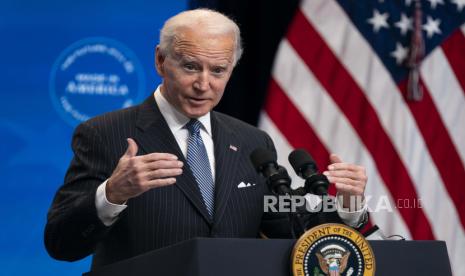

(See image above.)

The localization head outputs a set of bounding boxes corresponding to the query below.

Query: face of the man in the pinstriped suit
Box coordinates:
[156,29,234,118]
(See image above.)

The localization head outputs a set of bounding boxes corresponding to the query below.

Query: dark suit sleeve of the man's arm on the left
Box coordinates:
[44,123,113,261]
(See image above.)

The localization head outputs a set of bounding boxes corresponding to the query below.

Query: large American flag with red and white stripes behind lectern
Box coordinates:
[259,0,465,275]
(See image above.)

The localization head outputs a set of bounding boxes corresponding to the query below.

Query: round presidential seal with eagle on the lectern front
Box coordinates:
[291,223,375,276]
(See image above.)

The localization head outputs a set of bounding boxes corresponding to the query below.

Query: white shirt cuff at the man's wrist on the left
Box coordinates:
[95,180,128,226]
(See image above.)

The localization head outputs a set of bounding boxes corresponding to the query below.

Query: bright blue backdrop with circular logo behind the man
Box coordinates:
[0,0,187,275]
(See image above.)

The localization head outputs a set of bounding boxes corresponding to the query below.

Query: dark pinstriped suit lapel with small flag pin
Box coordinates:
[211,112,241,224]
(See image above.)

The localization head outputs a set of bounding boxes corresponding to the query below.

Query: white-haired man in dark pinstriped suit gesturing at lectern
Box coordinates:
[45,9,366,267]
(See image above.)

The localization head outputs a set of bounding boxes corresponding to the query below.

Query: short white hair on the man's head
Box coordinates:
[159,8,243,65]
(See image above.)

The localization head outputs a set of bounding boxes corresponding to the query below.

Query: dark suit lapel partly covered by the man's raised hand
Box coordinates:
[136,95,212,224]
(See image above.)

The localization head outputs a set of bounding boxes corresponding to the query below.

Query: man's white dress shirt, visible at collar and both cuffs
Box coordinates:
[95,86,367,227]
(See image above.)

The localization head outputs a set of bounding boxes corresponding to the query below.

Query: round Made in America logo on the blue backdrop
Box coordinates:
[50,37,145,126]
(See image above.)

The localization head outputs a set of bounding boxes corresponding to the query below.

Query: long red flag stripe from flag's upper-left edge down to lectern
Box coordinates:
[287,8,434,239]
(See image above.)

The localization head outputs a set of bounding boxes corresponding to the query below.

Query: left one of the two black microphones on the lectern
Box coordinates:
[250,148,292,195]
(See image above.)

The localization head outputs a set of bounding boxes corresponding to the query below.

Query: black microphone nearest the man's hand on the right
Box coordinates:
[288,149,329,196]
